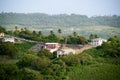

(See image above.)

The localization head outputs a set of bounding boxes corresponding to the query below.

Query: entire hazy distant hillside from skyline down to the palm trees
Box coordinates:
[0,13,120,37]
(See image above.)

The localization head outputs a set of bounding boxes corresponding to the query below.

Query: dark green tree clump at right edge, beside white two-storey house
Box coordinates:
[97,37,120,57]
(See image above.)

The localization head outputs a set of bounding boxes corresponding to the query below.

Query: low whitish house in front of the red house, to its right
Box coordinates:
[57,49,75,58]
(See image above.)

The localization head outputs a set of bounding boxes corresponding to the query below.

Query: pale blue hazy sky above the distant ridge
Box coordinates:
[0,0,120,16]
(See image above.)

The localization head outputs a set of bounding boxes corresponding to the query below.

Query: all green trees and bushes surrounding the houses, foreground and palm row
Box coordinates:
[0,23,120,80]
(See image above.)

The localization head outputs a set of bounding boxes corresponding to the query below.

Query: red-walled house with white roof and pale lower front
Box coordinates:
[45,43,60,53]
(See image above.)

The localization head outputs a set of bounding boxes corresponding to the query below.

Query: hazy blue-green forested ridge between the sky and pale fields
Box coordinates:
[0,13,120,27]
